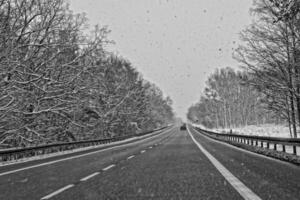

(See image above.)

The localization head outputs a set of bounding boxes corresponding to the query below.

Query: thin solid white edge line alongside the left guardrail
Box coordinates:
[0,128,174,176]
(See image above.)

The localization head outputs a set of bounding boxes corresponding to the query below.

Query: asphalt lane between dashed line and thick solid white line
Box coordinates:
[46,127,241,200]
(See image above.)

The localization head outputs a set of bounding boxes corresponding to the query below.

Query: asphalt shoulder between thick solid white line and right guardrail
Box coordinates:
[190,128,300,200]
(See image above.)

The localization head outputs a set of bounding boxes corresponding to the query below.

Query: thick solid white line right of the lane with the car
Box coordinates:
[187,128,261,200]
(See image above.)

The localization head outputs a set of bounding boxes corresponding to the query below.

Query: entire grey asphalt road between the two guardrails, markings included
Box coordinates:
[0,128,300,200]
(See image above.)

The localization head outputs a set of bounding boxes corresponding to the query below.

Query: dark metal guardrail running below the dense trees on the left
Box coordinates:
[0,126,169,162]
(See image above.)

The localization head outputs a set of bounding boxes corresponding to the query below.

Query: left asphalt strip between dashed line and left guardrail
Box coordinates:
[0,129,173,200]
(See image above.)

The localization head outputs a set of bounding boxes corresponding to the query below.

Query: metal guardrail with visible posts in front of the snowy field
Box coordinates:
[194,127,300,155]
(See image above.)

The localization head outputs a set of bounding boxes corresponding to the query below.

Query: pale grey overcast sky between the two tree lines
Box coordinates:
[69,0,252,118]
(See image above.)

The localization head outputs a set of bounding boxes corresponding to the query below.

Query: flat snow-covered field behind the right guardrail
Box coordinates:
[193,124,300,138]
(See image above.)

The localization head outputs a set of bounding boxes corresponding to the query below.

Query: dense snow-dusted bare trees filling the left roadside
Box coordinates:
[0,0,173,147]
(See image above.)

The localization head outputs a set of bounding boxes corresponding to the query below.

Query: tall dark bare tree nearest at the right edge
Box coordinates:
[236,0,300,137]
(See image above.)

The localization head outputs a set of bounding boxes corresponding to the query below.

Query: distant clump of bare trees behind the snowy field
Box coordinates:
[187,67,281,128]
